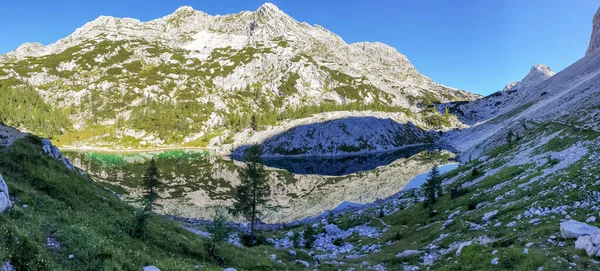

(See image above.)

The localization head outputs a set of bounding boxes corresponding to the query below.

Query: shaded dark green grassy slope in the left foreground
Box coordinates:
[0,137,296,271]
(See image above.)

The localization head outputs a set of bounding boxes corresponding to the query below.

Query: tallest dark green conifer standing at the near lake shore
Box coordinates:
[231,145,270,245]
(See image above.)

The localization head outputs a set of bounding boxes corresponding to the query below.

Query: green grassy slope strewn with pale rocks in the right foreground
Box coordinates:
[254,123,600,270]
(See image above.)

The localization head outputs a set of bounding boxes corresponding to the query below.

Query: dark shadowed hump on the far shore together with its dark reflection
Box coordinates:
[232,117,450,176]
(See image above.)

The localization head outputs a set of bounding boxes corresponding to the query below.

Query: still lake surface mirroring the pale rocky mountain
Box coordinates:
[65,146,453,223]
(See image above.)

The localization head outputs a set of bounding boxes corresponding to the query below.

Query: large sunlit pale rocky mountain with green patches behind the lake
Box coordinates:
[0,4,479,153]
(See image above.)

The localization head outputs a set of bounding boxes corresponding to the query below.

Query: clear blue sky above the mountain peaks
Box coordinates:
[0,0,600,95]
